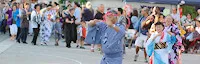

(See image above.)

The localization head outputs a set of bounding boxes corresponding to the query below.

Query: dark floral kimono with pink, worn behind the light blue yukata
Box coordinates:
[164,24,183,64]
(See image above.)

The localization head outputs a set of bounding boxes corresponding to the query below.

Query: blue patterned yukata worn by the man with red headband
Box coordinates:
[85,22,125,64]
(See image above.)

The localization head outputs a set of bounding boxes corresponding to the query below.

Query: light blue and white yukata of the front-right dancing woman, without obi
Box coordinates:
[146,32,176,64]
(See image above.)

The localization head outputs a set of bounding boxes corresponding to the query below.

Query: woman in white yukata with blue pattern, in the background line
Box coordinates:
[40,5,55,45]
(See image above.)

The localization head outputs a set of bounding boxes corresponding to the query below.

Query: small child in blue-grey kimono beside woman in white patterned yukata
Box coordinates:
[53,17,62,46]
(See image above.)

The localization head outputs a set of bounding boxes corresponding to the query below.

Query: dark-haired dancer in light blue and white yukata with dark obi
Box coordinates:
[146,22,176,64]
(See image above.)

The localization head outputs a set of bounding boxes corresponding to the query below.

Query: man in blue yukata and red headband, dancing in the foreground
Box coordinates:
[85,10,125,64]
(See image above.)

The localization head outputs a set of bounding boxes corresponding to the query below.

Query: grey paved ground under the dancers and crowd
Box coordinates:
[0,35,200,64]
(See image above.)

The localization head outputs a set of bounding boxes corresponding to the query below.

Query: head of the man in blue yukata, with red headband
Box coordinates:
[105,10,118,24]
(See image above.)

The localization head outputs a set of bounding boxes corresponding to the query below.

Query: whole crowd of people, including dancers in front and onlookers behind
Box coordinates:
[0,1,200,64]
